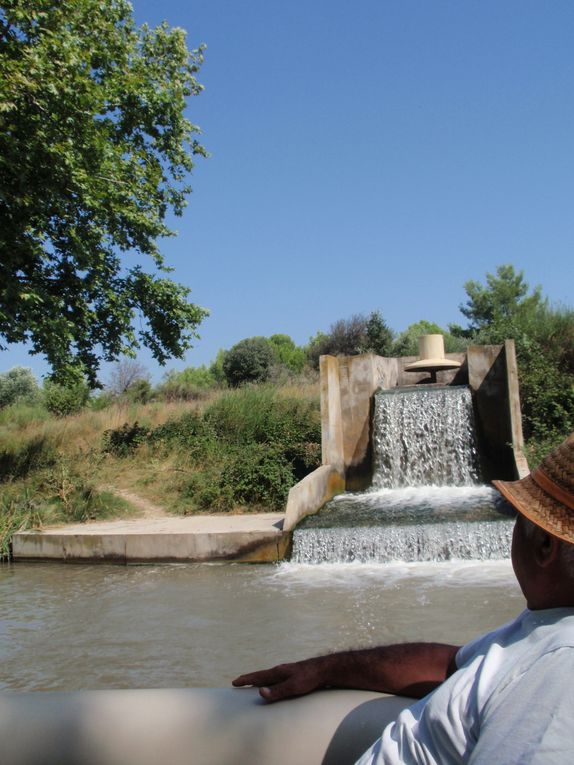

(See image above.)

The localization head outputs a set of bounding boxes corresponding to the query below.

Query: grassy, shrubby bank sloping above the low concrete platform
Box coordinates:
[0,383,321,557]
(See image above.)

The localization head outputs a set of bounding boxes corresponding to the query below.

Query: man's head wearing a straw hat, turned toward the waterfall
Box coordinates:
[494,433,574,609]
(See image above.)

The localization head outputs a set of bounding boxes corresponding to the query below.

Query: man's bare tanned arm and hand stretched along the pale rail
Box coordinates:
[233,643,458,701]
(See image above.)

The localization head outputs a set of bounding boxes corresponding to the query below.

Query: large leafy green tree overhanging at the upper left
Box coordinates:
[0,0,210,385]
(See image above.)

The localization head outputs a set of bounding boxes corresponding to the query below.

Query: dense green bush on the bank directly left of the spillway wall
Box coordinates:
[162,386,321,512]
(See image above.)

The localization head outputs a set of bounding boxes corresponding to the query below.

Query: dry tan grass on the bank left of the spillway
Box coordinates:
[0,380,319,536]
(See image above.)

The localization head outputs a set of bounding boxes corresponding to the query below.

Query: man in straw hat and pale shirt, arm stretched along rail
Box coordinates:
[234,433,574,765]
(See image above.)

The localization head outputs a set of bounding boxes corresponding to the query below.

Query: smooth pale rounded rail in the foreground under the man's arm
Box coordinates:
[0,688,412,765]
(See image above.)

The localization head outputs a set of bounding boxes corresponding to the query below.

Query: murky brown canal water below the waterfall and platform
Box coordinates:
[0,561,524,690]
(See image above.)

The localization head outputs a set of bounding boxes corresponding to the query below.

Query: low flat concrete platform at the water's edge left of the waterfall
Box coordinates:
[12,513,290,564]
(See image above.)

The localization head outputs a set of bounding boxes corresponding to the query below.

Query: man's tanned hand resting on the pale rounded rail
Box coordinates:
[233,656,326,701]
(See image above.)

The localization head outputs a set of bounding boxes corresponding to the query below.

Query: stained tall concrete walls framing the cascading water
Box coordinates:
[284,340,528,529]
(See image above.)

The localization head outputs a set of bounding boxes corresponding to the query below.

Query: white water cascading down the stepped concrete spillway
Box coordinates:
[292,387,513,563]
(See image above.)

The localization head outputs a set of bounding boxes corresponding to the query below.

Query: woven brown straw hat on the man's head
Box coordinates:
[493,433,574,544]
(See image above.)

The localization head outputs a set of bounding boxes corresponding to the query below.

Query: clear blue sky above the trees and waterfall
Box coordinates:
[0,0,574,381]
